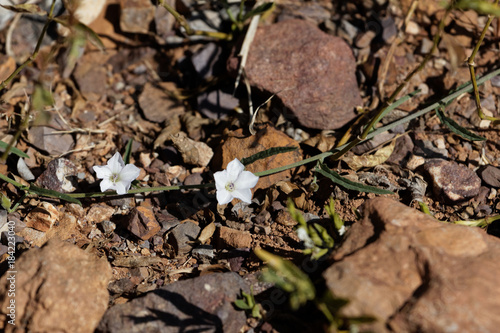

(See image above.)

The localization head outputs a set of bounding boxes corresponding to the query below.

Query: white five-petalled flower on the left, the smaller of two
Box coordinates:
[93,152,140,194]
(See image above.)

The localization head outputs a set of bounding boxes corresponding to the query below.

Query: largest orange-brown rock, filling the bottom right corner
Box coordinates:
[323,198,500,332]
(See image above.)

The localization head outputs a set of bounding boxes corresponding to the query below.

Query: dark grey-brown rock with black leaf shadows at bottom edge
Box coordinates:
[97,273,249,333]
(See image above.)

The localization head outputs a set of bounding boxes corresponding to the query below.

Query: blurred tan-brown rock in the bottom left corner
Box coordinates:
[0,241,111,333]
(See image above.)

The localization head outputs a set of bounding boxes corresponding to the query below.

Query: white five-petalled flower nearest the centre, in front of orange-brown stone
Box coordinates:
[214,158,259,205]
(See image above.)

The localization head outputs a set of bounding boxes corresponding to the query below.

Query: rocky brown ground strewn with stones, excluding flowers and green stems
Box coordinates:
[0,0,500,332]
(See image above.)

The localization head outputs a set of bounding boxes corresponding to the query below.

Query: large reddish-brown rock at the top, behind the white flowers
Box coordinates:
[229,19,363,130]
